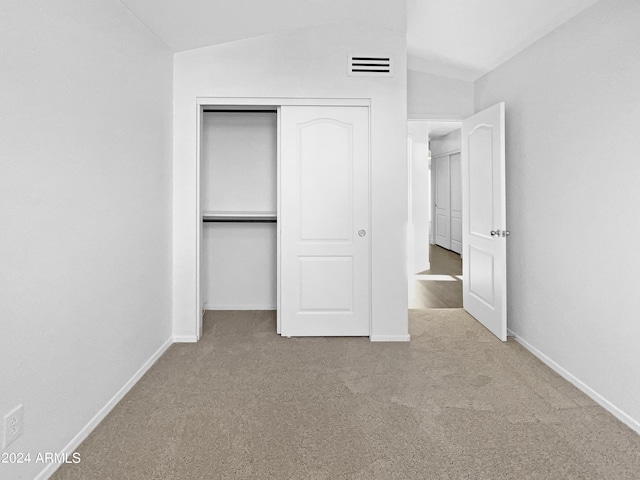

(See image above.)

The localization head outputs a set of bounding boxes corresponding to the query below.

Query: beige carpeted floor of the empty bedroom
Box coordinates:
[53,309,640,480]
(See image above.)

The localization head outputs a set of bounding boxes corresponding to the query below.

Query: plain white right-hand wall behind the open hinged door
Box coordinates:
[476,0,640,431]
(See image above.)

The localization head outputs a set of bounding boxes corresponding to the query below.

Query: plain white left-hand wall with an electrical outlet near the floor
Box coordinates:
[0,0,172,479]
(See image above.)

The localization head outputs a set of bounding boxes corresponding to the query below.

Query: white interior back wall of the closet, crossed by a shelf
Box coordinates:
[200,109,278,310]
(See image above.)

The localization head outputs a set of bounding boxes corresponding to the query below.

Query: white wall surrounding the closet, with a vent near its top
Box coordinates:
[173,24,407,339]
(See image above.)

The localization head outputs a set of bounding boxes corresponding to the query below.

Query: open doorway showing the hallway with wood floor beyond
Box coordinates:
[408,120,463,309]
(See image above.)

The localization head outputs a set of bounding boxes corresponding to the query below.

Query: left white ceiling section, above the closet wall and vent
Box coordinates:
[120,0,407,52]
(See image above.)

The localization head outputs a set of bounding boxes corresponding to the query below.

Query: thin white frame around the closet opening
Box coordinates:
[194,97,372,340]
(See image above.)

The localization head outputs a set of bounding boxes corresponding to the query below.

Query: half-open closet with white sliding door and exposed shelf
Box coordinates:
[197,99,371,336]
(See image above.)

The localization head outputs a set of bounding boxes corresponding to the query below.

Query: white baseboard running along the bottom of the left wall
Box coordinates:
[34,338,173,480]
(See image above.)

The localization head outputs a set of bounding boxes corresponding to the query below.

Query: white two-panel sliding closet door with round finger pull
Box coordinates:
[278,106,370,336]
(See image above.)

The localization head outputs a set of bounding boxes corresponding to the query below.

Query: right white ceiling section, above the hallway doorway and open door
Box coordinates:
[407,0,597,81]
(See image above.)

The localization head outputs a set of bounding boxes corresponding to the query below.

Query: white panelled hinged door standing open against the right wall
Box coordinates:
[462,103,509,341]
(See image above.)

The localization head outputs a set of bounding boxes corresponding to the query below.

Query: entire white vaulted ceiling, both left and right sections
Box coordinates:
[121,0,597,81]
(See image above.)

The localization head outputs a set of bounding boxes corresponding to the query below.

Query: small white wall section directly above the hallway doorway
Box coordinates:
[407,69,474,120]
